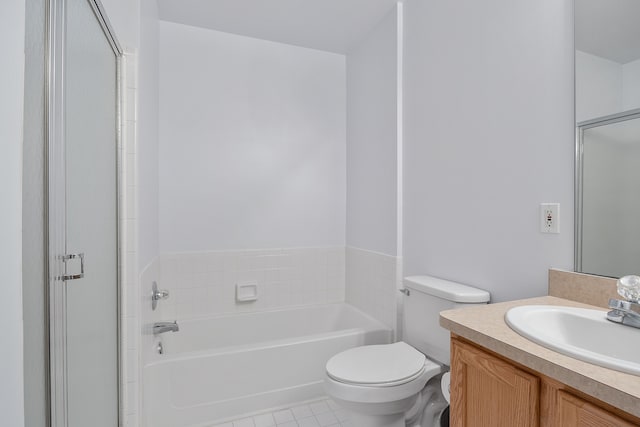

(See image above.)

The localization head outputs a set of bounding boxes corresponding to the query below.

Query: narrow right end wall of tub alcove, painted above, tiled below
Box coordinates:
[345,8,400,329]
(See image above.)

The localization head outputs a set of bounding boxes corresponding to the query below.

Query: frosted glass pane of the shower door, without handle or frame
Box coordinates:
[65,0,118,427]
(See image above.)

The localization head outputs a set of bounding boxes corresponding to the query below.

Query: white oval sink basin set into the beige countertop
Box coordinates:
[505,305,640,375]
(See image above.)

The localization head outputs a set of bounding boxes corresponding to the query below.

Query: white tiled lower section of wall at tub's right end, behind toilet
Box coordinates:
[345,247,401,330]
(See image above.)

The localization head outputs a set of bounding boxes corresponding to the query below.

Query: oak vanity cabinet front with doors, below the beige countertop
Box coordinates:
[450,335,640,427]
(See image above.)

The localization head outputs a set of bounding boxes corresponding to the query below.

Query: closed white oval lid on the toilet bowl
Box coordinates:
[327,342,426,386]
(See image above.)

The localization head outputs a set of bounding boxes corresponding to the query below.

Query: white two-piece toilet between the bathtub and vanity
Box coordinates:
[324,276,490,427]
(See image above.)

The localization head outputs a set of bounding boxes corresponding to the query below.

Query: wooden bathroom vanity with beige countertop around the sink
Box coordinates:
[440,296,640,427]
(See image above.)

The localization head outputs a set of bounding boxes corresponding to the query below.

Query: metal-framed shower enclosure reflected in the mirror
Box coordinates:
[575,110,640,277]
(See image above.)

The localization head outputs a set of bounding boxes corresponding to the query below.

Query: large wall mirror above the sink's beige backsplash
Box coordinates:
[575,0,640,277]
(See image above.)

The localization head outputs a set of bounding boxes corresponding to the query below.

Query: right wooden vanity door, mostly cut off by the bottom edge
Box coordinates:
[553,390,636,427]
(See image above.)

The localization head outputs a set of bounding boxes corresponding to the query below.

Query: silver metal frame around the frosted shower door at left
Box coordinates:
[44,0,124,427]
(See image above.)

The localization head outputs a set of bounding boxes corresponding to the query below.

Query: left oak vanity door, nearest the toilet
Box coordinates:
[451,339,540,427]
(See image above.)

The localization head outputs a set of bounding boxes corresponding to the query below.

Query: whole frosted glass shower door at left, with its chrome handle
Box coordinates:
[50,0,119,427]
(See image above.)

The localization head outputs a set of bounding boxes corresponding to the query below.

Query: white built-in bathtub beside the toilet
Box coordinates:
[143,304,391,427]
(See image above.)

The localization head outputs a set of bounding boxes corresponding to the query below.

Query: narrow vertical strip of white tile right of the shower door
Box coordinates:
[119,51,140,427]
